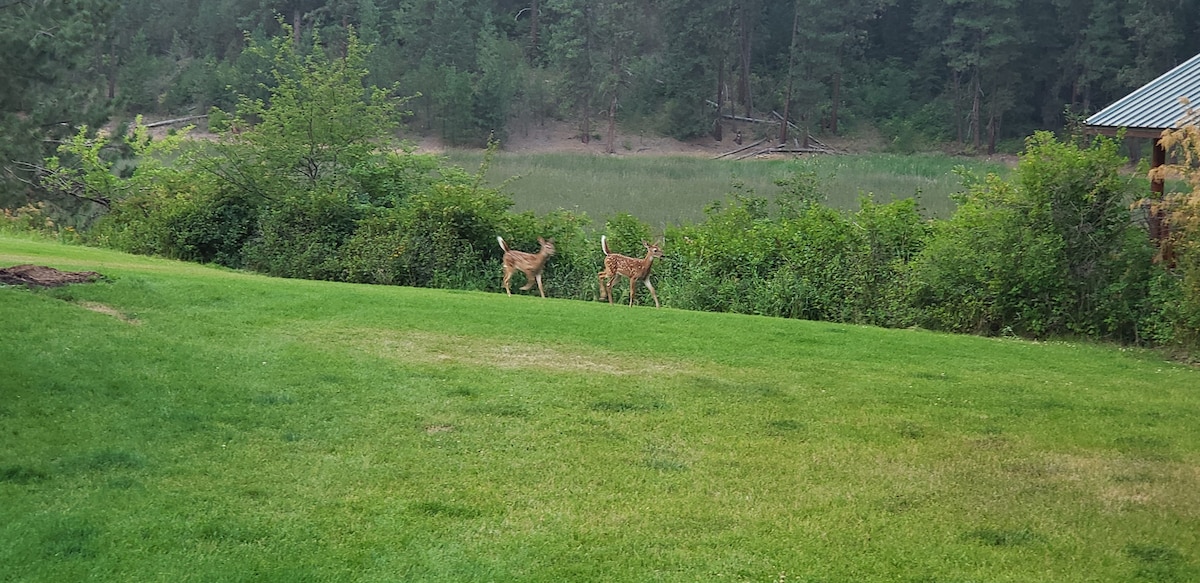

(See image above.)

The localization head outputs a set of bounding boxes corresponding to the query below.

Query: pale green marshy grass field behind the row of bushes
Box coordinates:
[446,150,1008,229]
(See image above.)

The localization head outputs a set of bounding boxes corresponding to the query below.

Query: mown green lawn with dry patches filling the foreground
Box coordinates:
[0,235,1200,583]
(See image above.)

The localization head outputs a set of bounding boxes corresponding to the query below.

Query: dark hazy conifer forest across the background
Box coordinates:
[0,0,1200,172]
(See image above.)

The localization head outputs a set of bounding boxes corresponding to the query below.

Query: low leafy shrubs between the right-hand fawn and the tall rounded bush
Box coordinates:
[661,190,925,325]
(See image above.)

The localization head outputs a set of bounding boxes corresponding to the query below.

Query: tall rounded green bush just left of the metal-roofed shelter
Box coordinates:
[912,133,1150,339]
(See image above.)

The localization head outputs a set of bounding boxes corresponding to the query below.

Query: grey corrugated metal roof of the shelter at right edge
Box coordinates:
[1084,54,1200,138]
